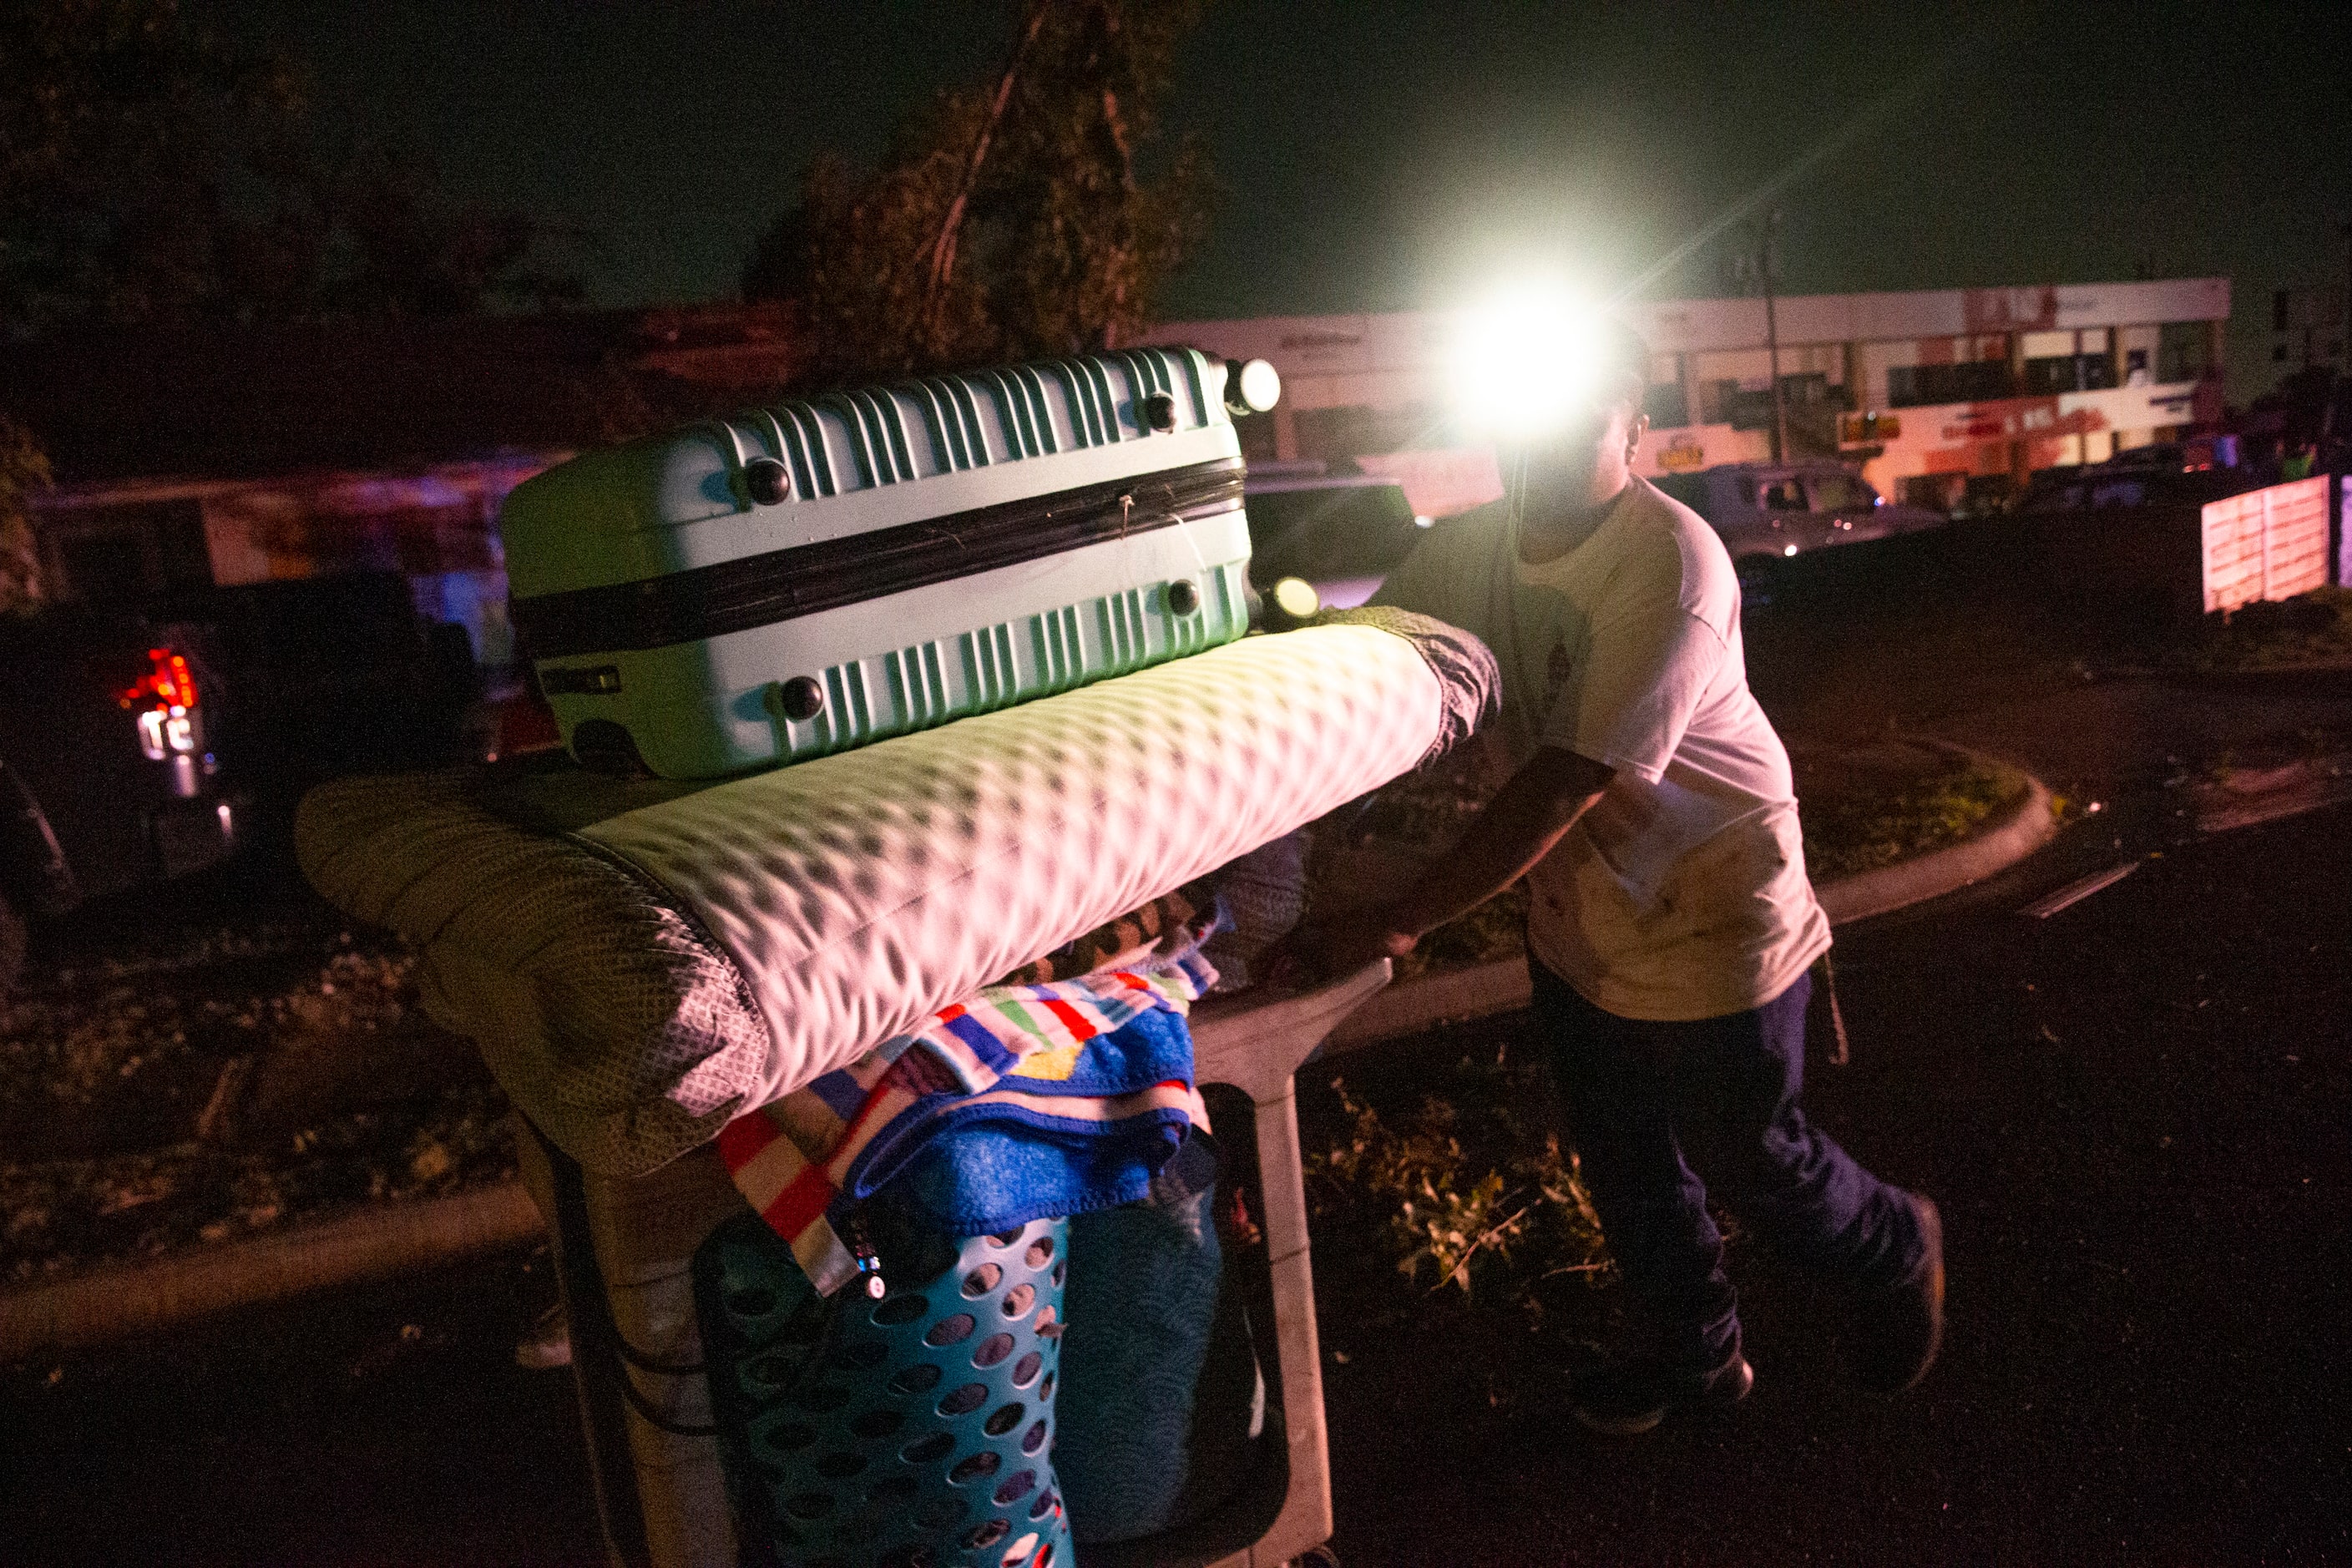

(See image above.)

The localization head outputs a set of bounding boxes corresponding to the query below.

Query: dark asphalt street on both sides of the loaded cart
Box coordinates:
[0,747,2352,1568]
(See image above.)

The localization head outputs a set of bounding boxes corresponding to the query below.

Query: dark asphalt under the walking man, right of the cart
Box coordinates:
[1324,766,2352,1568]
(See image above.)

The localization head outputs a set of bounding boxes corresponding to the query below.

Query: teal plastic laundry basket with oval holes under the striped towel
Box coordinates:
[694,1213,1073,1568]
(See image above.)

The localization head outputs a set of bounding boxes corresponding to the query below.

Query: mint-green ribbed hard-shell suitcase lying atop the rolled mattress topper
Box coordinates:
[498,348,1270,778]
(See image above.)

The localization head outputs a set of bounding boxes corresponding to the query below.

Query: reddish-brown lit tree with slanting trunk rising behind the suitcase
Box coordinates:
[743,0,1211,381]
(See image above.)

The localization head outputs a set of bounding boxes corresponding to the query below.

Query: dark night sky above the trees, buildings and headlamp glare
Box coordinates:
[190,0,2352,397]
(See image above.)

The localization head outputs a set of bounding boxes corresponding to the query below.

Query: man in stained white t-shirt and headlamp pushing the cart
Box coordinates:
[1308,325,1943,1434]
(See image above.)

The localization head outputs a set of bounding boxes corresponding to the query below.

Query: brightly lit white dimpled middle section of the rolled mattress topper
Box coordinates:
[579,625,1451,1103]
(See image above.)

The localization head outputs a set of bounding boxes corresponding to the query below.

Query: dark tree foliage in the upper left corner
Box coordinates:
[0,0,579,331]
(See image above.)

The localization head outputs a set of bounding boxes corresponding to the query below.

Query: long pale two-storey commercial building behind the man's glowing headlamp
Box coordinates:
[1152,277,2230,515]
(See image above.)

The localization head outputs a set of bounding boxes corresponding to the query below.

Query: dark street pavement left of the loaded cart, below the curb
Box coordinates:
[0,1257,604,1568]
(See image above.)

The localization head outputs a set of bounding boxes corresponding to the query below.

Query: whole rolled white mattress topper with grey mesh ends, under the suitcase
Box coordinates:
[294,609,1496,1176]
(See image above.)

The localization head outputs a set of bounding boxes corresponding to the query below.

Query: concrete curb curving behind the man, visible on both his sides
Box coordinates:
[1322,743,2058,1055]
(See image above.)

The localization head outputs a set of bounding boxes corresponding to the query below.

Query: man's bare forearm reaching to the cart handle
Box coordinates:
[1305,746,1616,974]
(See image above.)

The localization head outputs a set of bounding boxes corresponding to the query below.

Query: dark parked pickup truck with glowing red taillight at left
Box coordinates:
[0,571,484,999]
